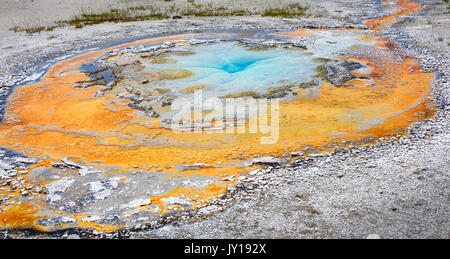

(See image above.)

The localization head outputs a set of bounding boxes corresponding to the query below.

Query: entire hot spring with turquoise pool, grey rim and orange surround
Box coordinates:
[0,0,434,236]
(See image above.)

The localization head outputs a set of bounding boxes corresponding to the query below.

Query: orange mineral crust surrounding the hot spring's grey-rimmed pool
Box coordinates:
[0,0,434,232]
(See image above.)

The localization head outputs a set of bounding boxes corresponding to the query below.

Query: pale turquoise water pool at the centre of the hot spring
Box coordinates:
[145,42,320,97]
